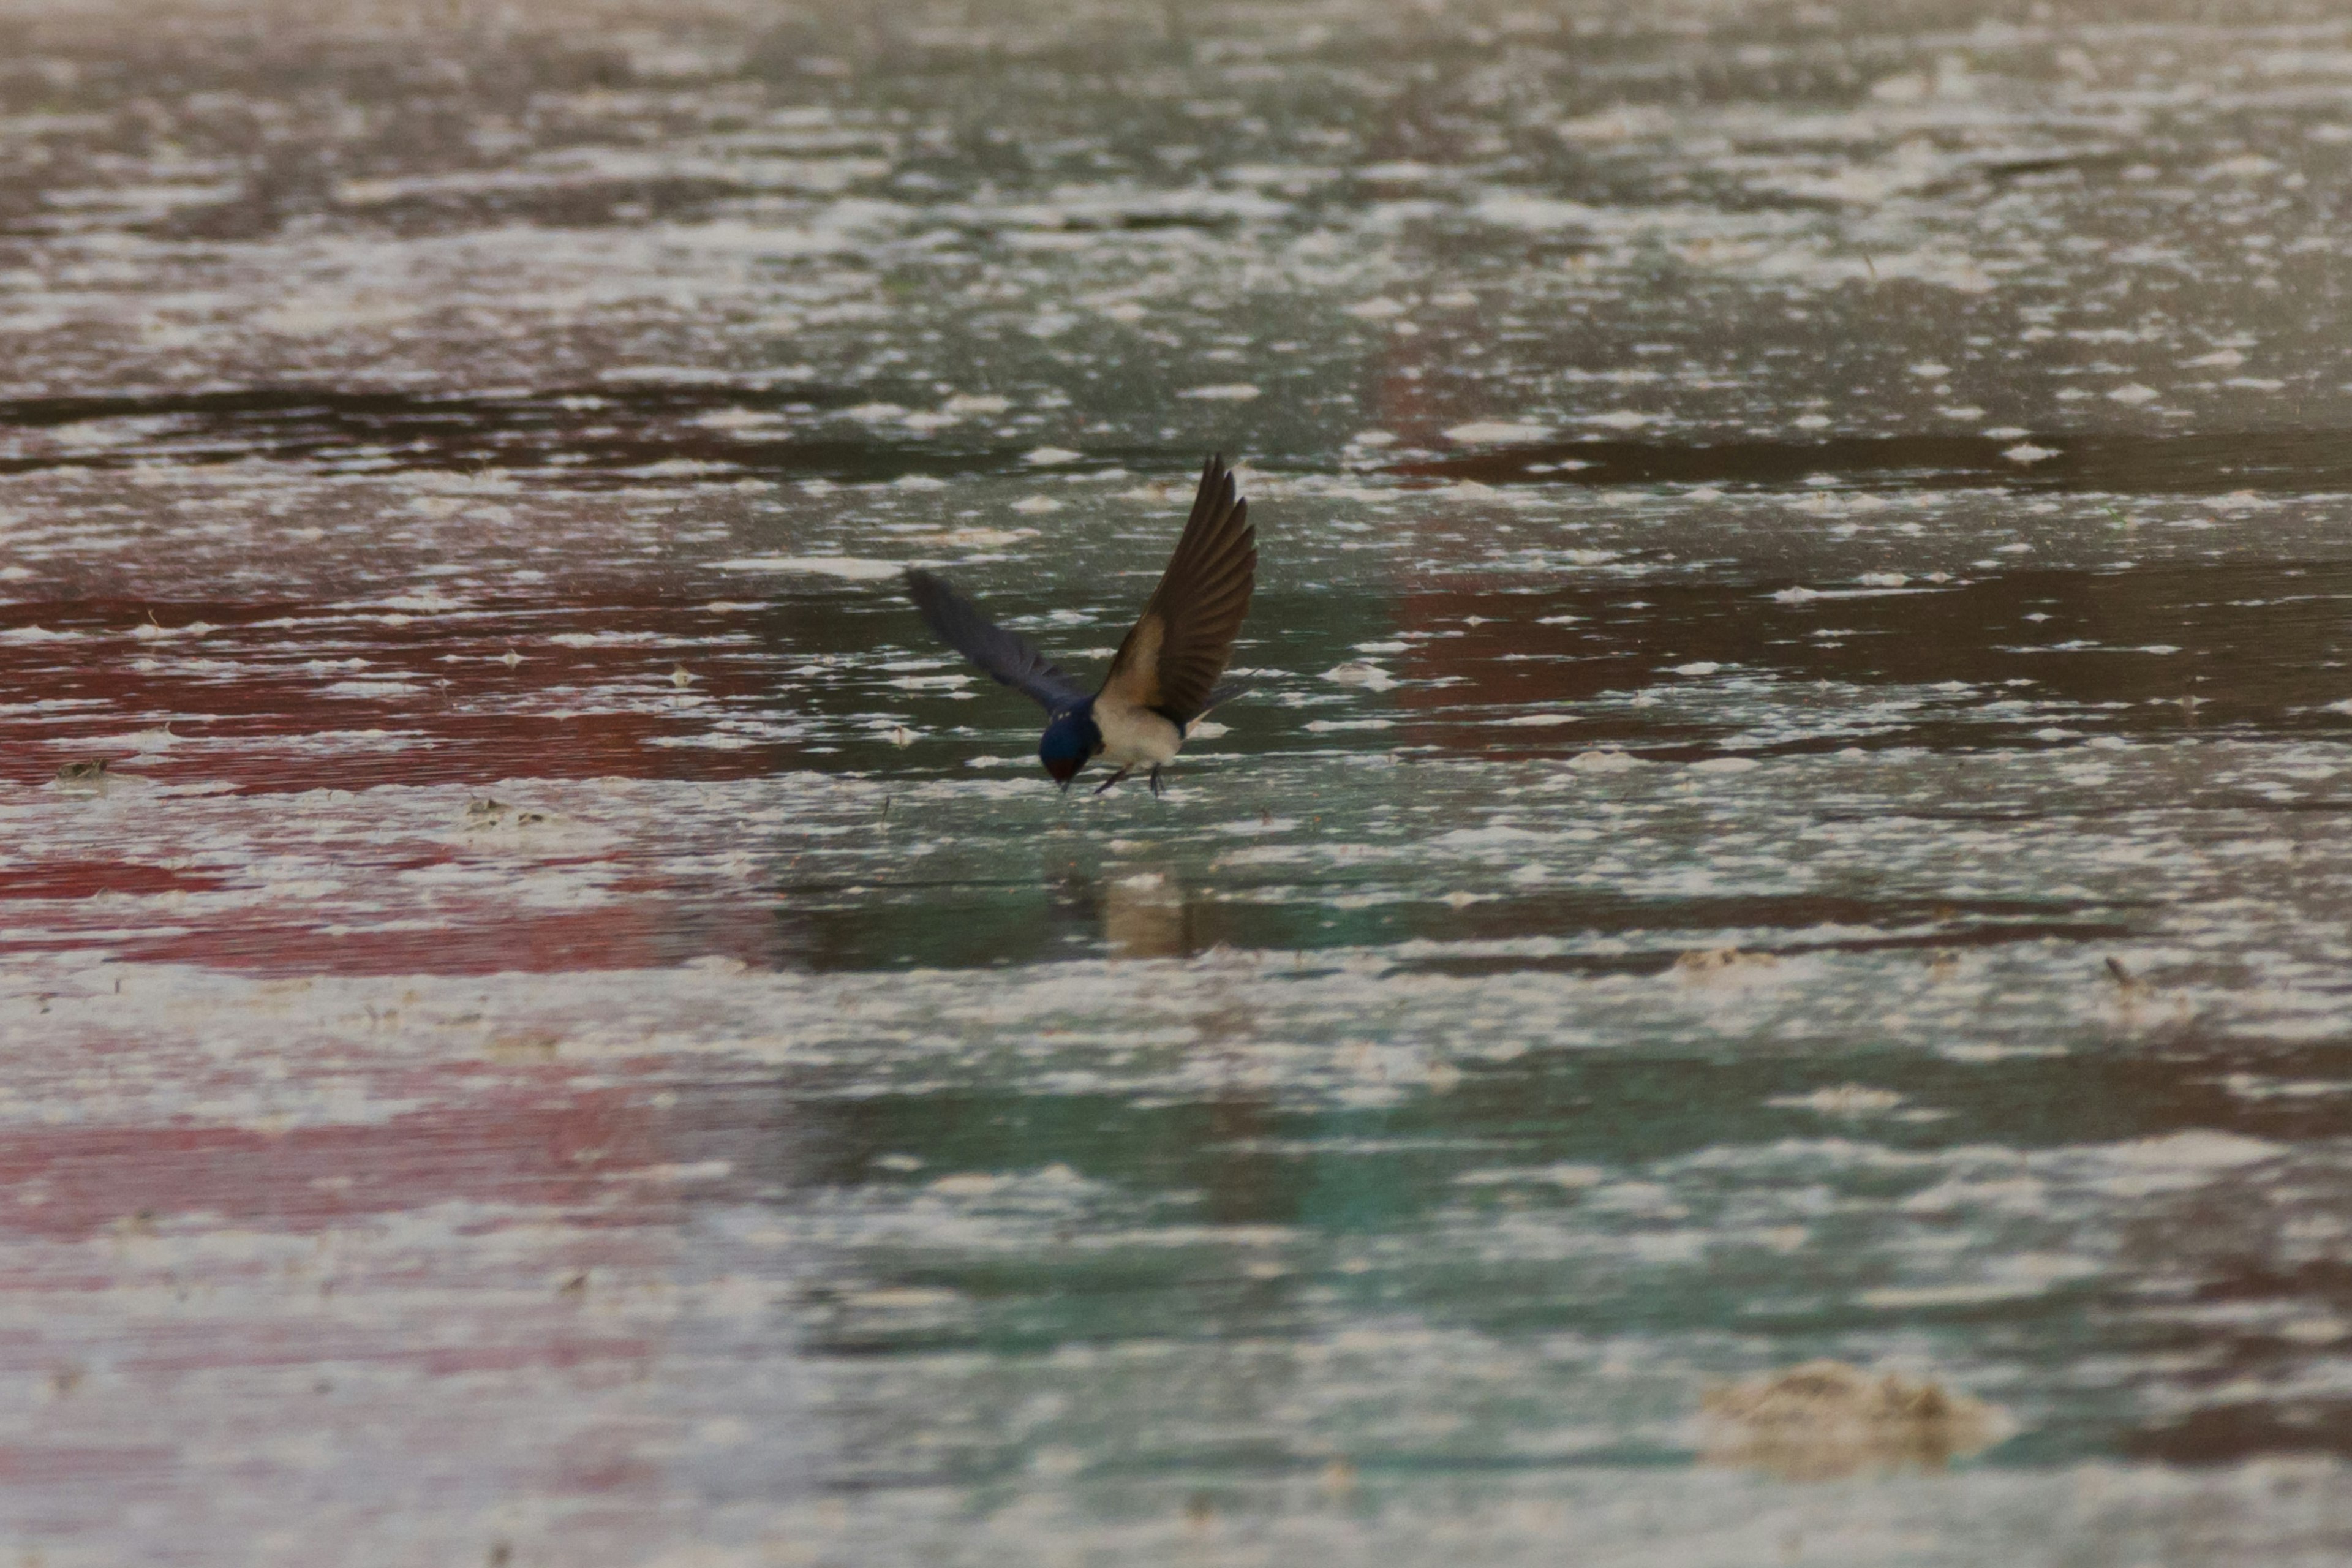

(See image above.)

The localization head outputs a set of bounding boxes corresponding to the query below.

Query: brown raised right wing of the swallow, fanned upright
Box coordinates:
[1103,456,1258,724]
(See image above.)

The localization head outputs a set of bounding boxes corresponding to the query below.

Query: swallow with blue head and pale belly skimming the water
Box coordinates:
[905,456,1258,794]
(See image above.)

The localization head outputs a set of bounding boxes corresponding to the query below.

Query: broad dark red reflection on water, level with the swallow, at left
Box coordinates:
[0,592,783,790]
